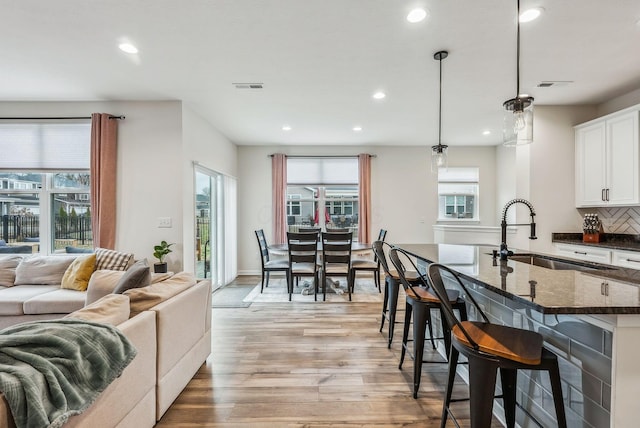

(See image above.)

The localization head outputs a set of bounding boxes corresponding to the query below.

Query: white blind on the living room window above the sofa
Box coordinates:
[0,121,91,171]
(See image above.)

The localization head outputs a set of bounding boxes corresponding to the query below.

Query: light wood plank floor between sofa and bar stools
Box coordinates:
[156,277,501,428]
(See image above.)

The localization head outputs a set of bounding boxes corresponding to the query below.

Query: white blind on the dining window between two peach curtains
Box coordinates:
[287,157,358,186]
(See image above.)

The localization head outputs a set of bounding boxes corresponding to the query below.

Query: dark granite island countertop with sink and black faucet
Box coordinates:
[396,244,640,314]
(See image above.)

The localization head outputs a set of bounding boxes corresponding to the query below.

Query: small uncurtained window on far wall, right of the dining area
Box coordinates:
[438,168,479,221]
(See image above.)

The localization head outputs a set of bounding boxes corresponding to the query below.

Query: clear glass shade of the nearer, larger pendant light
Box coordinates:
[502,97,533,147]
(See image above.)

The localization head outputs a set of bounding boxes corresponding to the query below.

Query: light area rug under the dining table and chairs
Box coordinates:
[243,278,382,303]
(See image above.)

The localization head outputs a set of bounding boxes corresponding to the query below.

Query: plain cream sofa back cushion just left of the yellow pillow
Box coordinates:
[14,256,75,286]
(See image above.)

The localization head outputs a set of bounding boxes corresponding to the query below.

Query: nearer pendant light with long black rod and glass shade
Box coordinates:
[502,0,533,146]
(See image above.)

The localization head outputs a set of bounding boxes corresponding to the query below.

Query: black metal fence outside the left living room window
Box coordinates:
[0,215,93,247]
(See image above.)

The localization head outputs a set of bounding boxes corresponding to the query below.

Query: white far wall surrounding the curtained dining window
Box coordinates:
[238,146,496,275]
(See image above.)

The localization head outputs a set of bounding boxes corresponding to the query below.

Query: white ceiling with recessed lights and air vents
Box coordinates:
[0,0,640,145]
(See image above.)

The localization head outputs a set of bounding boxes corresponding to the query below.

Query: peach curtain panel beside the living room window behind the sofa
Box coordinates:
[91,113,118,249]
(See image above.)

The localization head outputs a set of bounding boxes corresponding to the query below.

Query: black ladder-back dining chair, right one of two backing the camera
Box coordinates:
[321,232,353,301]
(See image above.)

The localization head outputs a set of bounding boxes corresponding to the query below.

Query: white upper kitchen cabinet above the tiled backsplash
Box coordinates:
[575,109,640,207]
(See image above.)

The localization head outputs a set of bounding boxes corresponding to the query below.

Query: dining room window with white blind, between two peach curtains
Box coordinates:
[287,157,359,234]
